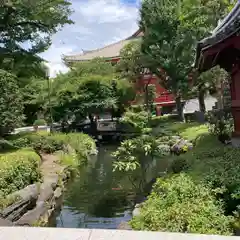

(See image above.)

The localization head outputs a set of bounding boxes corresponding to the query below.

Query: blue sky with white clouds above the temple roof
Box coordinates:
[41,0,141,77]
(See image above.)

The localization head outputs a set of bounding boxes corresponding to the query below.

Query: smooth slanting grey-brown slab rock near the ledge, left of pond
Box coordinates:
[15,202,48,226]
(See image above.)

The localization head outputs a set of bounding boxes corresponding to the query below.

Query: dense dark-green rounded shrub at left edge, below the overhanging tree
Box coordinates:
[0,69,23,136]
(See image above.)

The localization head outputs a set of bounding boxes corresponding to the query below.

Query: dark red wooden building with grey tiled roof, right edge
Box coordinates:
[195,1,240,137]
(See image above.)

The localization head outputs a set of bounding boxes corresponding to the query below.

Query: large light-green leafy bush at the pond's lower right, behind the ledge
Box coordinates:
[131,174,233,235]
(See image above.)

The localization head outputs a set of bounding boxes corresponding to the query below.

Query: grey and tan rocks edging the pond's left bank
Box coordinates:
[0,155,70,226]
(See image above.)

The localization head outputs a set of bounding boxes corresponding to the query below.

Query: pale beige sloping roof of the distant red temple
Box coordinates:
[63,30,143,62]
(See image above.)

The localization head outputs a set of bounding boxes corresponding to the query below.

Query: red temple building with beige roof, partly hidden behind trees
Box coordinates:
[64,30,175,115]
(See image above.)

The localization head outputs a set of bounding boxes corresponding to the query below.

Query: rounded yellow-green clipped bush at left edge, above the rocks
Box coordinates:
[0,149,41,197]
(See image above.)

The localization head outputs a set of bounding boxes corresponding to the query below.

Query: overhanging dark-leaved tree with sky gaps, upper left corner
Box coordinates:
[0,0,72,71]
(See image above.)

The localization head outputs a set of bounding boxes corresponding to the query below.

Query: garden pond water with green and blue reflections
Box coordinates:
[50,145,135,229]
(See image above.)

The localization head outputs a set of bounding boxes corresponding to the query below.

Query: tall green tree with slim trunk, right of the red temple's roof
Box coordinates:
[140,0,235,120]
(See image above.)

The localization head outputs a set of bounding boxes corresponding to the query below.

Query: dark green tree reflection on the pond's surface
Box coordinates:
[65,145,134,217]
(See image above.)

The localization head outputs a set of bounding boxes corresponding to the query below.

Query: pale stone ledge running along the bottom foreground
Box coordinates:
[0,227,240,240]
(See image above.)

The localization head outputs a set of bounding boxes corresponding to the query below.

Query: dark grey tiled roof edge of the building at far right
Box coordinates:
[194,1,240,71]
